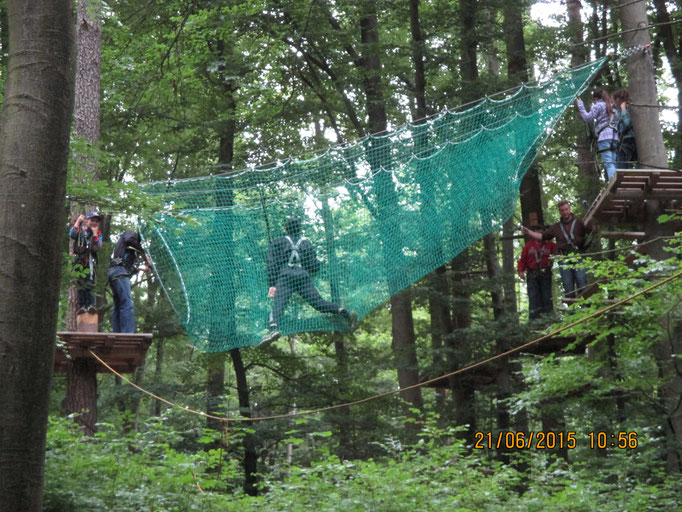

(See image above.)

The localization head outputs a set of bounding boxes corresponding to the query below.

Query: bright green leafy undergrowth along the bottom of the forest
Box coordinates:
[45,416,682,512]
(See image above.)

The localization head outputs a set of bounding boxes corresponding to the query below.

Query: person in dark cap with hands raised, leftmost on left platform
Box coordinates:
[69,212,102,314]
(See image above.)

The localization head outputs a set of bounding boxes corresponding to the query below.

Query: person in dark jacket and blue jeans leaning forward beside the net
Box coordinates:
[107,230,151,333]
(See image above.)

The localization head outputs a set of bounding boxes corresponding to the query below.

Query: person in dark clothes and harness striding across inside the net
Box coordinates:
[259,218,352,346]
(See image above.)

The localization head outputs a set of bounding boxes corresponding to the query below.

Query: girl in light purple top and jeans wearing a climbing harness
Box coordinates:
[576,89,619,180]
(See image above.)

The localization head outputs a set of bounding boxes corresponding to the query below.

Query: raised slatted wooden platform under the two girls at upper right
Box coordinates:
[583,169,682,224]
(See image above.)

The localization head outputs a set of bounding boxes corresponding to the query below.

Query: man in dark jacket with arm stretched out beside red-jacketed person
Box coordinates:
[521,201,591,298]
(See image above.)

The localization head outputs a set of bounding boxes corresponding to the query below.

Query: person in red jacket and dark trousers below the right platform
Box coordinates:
[517,226,557,320]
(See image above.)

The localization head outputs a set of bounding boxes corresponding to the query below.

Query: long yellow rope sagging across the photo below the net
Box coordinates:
[90,270,682,425]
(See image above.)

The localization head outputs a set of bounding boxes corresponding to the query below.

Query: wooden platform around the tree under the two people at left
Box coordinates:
[54,332,153,373]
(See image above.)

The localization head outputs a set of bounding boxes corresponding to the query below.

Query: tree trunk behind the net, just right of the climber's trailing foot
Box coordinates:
[360,0,424,432]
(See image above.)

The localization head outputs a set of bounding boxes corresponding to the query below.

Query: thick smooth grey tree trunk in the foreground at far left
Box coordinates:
[0,0,75,512]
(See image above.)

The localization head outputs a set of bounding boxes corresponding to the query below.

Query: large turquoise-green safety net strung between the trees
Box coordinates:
[140,59,604,352]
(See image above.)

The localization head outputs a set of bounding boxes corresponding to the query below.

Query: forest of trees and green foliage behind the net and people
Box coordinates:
[0,0,682,511]
